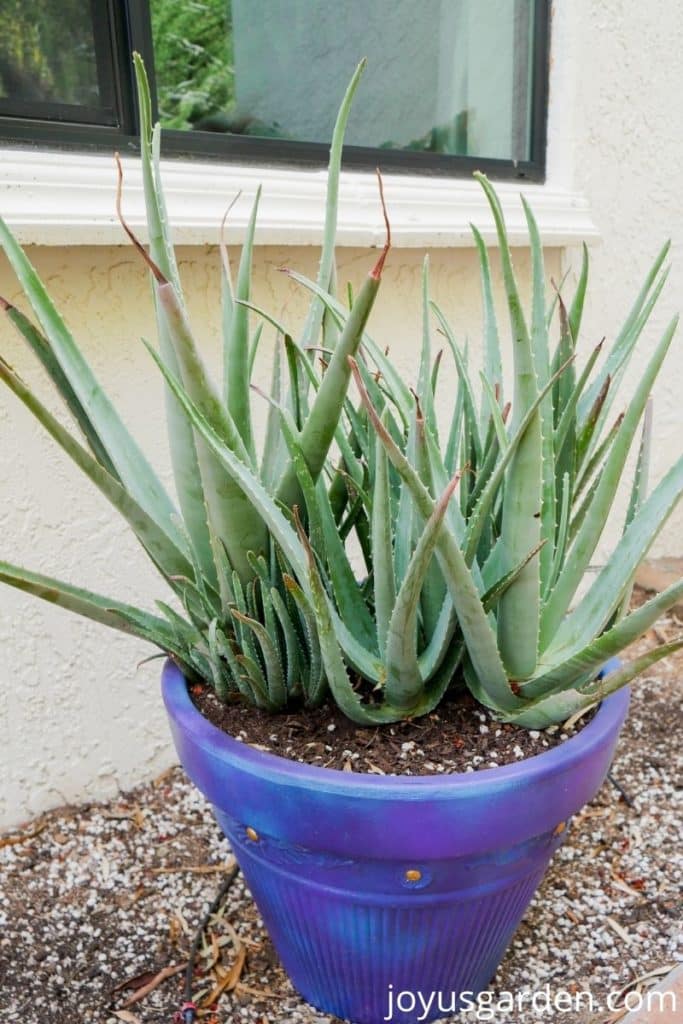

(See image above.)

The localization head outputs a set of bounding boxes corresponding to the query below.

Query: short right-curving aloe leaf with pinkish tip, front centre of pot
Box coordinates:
[385,473,460,713]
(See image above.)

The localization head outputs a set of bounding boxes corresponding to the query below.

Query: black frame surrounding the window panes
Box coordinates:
[0,0,550,182]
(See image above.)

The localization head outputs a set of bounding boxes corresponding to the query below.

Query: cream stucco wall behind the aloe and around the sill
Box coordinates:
[0,0,683,827]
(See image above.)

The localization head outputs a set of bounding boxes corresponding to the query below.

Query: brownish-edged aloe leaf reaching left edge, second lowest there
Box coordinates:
[0,358,194,580]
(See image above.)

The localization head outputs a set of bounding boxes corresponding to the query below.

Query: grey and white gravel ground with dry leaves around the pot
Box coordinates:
[0,621,683,1024]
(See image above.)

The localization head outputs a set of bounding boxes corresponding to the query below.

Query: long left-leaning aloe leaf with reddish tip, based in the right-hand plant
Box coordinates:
[353,368,516,707]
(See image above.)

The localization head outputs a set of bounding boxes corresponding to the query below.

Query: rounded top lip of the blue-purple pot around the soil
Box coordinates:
[162,659,630,799]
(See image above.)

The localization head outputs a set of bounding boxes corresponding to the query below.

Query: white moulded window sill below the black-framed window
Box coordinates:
[0,148,599,247]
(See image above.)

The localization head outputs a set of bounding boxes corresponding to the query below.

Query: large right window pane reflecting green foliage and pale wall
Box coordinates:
[152,0,533,160]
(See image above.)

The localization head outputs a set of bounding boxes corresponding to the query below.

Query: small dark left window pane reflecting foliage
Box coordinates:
[0,0,102,113]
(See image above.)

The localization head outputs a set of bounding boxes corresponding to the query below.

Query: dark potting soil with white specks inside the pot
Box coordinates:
[190,685,595,775]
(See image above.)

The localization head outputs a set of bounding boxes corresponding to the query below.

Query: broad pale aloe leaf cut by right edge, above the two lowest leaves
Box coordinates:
[543,458,683,663]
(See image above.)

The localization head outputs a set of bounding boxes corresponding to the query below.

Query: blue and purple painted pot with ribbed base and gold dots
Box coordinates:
[163,663,629,1024]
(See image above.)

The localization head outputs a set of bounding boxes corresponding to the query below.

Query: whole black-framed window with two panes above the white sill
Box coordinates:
[0,0,549,180]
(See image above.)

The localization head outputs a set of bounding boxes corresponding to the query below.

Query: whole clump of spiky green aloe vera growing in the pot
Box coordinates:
[0,59,683,727]
